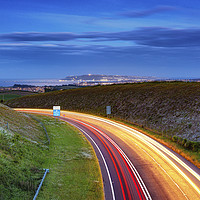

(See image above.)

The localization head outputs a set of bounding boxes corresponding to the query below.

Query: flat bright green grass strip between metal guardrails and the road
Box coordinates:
[33,115,104,200]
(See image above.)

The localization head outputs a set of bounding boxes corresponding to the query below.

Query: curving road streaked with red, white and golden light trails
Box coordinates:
[17,109,200,200]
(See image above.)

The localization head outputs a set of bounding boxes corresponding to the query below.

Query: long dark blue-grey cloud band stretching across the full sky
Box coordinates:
[0,27,200,48]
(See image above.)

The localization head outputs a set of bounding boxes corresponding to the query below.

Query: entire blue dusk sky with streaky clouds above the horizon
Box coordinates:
[0,0,200,79]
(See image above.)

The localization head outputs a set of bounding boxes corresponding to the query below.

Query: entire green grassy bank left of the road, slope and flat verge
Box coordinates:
[0,104,103,200]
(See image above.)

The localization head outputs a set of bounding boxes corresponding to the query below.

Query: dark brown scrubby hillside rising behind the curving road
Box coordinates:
[6,82,200,141]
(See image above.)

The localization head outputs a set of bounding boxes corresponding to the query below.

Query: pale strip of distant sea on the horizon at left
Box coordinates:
[0,79,75,87]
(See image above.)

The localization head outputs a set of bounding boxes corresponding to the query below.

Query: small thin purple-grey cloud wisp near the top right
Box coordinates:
[119,6,177,18]
